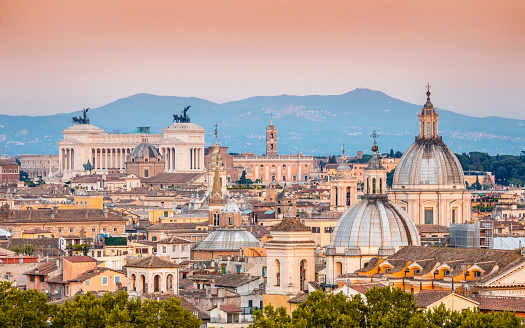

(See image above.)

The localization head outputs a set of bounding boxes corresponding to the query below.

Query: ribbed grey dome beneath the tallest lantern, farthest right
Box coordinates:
[393,138,465,189]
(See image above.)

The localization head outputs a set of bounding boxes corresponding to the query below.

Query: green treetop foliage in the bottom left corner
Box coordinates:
[0,282,201,328]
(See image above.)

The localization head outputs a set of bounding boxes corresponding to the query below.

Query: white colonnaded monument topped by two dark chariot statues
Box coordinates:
[58,123,206,179]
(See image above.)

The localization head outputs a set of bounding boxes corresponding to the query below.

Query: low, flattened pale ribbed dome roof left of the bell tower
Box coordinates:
[194,228,261,250]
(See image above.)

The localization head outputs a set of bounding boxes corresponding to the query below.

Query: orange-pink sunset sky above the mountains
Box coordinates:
[0,0,525,119]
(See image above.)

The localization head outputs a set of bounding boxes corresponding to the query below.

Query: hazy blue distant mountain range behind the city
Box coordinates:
[0,89,525,156]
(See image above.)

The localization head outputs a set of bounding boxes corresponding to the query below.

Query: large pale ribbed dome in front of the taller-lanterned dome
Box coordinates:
[330,195,420,247]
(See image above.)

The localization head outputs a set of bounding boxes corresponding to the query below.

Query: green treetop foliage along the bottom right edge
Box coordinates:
[250,287,522,328]
